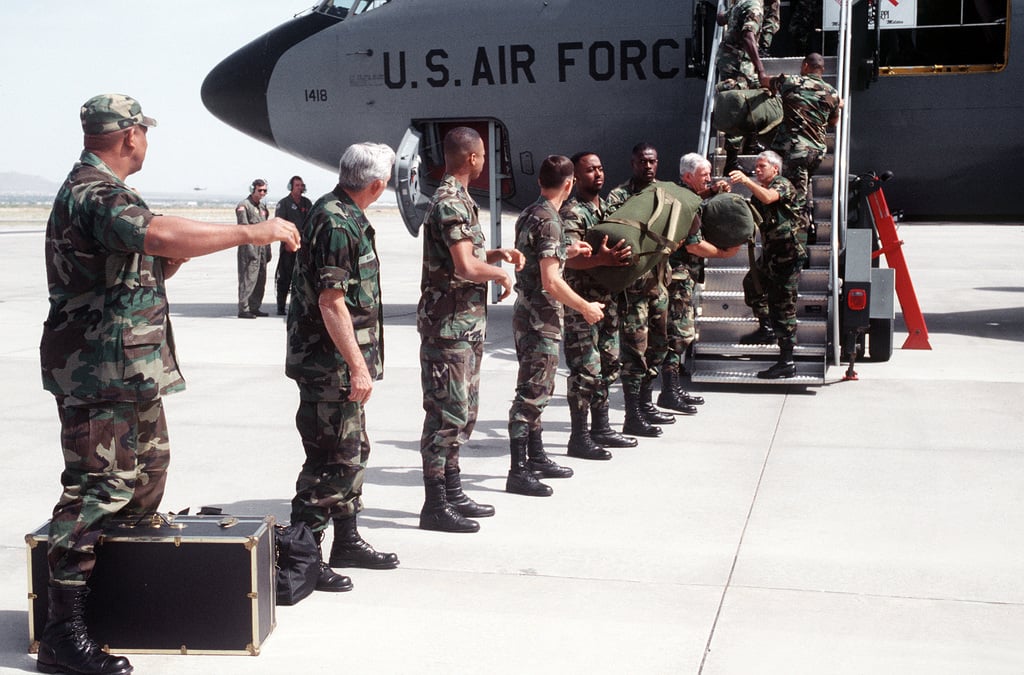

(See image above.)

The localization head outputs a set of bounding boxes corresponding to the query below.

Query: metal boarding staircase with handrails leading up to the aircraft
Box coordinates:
[687,2,850,385]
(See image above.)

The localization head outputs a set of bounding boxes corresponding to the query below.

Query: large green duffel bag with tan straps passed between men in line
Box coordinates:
[587,180,700,293]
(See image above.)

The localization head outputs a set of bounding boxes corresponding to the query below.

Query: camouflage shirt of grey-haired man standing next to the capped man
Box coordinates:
[285,186,384,400]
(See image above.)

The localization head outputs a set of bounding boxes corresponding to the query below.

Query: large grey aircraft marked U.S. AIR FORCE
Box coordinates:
[202,0,1024,218]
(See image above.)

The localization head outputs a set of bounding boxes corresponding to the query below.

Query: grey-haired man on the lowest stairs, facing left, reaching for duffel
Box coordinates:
[729,151,807,380]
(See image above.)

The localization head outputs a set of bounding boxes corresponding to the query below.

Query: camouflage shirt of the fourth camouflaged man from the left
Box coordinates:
[512,197,565,339]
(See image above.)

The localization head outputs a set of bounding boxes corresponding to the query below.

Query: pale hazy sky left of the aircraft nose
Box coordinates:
[0,0,336,199]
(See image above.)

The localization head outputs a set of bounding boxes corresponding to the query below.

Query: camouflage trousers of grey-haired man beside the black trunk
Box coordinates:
[292,400,370,532]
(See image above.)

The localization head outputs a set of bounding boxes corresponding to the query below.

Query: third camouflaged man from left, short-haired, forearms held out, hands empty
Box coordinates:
[416,127,523,532]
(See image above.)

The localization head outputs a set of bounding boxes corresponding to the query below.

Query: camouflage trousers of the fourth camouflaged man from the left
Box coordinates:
[509,330,559,438]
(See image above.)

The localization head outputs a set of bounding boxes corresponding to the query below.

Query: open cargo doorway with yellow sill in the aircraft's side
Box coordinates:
[824,0,1010,75]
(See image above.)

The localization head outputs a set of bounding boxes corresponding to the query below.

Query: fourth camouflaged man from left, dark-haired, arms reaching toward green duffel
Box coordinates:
[505,155,604,497]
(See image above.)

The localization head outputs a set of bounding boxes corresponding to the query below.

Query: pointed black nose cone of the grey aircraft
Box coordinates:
[200,12,341,145]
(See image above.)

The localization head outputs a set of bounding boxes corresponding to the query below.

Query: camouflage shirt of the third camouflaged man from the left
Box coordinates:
[416,174,487,342]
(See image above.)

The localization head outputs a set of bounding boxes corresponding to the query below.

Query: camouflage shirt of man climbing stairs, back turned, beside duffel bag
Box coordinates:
[771,74,839,158]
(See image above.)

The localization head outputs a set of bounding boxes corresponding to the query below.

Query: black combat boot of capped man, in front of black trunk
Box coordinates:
[36,582,132,675]
